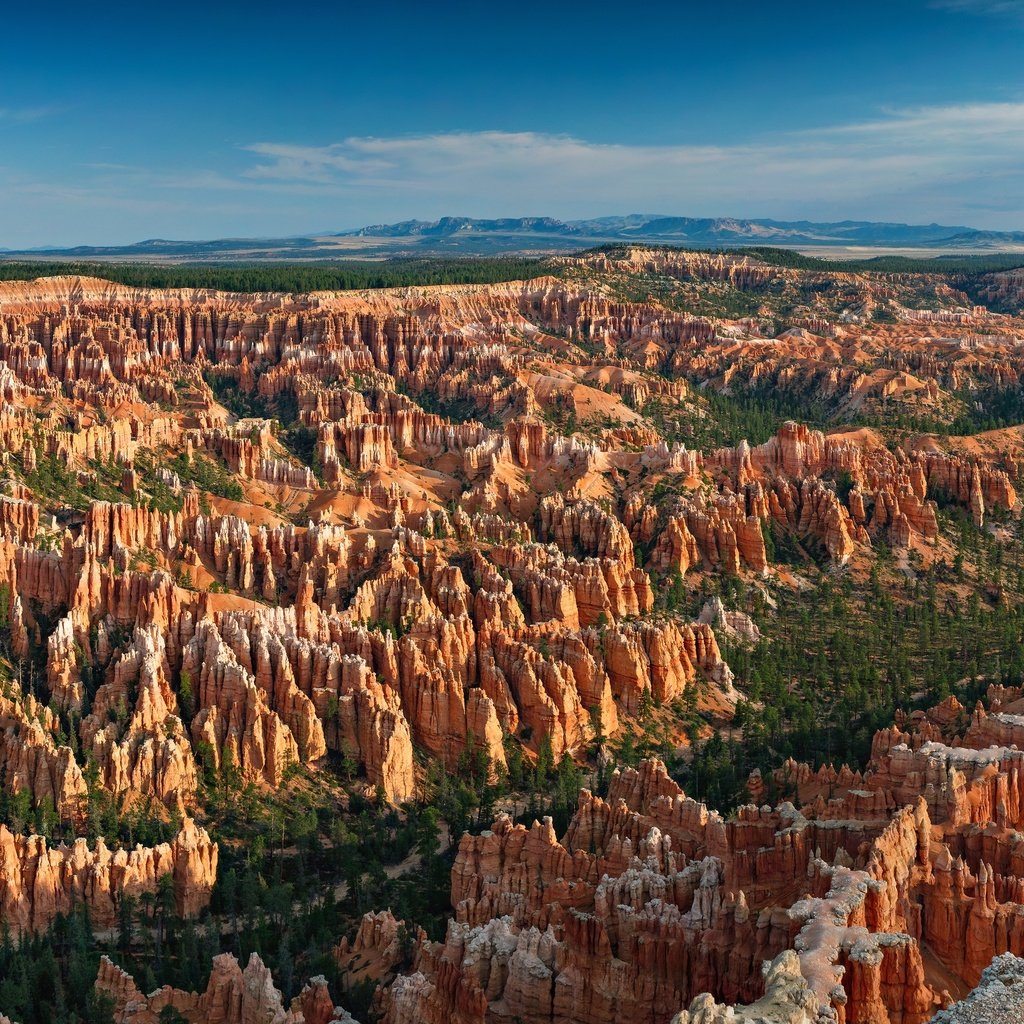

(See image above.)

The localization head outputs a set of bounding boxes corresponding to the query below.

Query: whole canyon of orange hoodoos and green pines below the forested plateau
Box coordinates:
[0,246,1024,1024]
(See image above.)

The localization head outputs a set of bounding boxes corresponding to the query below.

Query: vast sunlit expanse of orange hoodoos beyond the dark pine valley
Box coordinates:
[0,264,1017,816]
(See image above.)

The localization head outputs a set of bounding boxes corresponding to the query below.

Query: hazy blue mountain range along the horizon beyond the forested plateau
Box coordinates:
[8,214,1024,262]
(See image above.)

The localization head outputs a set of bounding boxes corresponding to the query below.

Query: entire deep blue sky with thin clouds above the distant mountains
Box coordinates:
[6,0,1024,248]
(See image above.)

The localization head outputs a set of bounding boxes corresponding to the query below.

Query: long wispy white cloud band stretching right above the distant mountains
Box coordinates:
[234,102,1024,226]
